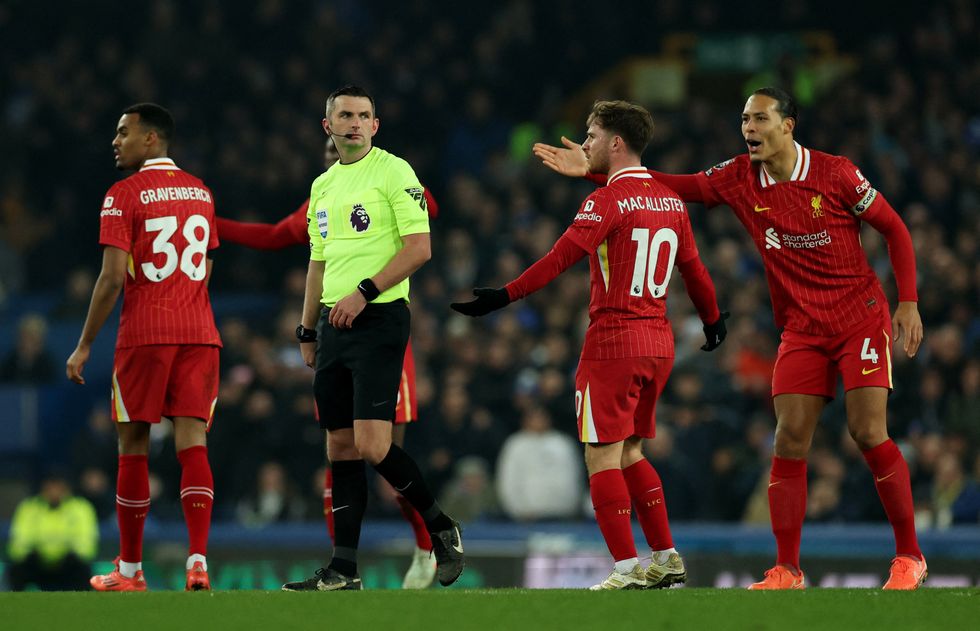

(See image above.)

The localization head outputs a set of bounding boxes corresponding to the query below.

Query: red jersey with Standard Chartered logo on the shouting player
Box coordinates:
[697,143,888,336]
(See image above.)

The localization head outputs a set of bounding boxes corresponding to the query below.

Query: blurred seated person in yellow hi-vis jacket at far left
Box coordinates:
[7,471,99,592]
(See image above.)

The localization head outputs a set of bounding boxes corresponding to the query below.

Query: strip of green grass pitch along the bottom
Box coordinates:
[0,588,980,631]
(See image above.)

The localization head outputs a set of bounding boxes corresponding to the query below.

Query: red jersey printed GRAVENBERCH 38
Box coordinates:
[99,158,221,348]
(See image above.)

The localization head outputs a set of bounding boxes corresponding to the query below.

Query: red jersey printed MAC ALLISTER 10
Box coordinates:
[565,167,698,359]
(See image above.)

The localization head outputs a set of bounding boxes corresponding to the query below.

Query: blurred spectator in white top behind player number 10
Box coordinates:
[497,408,585,521]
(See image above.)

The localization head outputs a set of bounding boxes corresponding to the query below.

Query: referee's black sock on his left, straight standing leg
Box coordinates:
[330,460,367,576]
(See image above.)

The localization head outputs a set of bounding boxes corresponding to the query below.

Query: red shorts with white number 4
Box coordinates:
[772,309,892,399]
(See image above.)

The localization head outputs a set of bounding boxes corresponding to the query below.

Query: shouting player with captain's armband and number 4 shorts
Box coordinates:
[534,88,926,590]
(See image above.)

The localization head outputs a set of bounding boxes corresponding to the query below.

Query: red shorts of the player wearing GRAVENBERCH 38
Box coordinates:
[112,344,218,428]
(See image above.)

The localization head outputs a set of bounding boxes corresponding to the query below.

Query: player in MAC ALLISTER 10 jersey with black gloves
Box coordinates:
[452,101,727,590]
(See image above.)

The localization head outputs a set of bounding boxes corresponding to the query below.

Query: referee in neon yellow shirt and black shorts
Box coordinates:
[283,86,464,591]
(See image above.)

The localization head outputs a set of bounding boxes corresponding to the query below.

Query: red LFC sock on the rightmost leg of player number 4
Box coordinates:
[864,438,922,558]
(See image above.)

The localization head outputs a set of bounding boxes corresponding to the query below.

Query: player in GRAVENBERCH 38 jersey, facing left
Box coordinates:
[66,103,221,591]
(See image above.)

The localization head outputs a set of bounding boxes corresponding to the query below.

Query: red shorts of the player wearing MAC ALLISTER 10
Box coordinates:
[575,357,674,443]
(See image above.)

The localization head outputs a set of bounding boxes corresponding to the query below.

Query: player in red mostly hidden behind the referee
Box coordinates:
[218,138,439,589]
